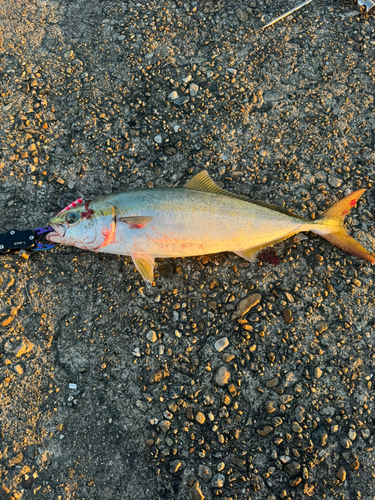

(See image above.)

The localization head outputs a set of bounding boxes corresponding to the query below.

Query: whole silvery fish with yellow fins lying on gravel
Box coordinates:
[47,170,375,285]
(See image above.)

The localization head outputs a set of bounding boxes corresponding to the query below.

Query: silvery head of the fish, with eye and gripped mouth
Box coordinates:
[46,203,103,250]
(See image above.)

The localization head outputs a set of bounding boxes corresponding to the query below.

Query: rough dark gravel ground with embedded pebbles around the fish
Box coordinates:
[0,0,375,500]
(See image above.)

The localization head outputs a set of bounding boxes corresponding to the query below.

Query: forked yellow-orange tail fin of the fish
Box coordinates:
[313,189,375,264]
